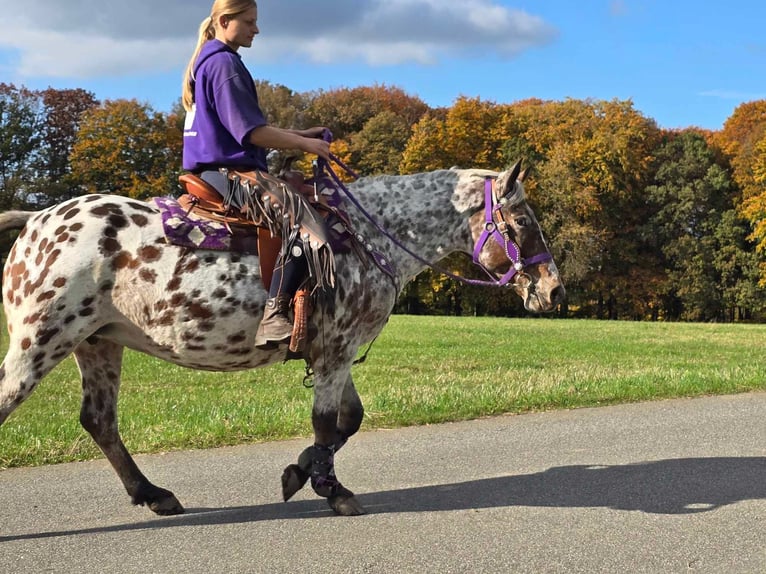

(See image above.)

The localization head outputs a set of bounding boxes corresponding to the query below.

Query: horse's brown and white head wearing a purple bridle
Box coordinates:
[462,162,566,313]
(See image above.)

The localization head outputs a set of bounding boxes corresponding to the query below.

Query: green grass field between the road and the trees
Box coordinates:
[0,315,766,468]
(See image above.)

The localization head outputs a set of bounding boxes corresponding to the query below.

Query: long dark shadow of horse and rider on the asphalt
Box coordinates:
[0,457,766,542]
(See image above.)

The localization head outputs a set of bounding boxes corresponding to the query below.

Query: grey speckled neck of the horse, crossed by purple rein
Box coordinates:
[350,171,470,284]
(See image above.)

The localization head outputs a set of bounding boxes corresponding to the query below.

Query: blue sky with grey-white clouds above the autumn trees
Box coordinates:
[0,0,766,130]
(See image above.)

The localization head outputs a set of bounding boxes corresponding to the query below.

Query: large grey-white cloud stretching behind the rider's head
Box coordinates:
[0,0,556,78]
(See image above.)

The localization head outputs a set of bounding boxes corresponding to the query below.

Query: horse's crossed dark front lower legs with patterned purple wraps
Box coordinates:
[282,374,364,516]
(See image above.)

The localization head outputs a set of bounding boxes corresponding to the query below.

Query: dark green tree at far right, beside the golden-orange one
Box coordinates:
[643,131,763,321]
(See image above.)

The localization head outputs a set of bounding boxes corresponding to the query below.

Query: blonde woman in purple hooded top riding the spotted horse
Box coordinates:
[182,0,330,347]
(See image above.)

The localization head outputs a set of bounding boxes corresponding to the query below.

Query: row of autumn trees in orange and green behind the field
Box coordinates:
[0,82,766,321]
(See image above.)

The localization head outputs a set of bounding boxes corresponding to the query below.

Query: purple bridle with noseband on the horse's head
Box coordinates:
[473,177,553,287]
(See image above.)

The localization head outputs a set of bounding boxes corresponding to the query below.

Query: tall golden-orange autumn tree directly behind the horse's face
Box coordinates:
[506,100,659,318]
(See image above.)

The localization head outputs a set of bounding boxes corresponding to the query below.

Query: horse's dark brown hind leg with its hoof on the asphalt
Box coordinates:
[74,339,184,515]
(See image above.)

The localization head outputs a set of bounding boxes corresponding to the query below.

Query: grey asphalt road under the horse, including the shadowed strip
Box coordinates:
[0,393,766,574]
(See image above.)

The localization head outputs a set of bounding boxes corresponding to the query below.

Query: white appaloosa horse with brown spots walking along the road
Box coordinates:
[0,164,564,515]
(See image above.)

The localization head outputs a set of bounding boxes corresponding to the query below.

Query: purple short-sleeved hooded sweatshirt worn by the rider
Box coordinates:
[183,40,267,172]
